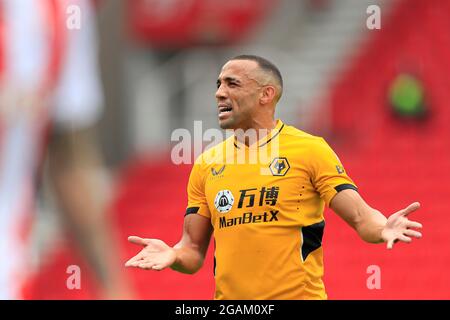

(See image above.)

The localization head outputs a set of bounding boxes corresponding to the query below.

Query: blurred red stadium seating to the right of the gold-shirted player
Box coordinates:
[324,0,450,299]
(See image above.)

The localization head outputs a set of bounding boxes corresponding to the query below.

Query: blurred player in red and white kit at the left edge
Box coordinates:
[0,0,129,299]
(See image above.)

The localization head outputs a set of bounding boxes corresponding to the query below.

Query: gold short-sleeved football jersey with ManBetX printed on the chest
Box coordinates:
[186,120,356,300]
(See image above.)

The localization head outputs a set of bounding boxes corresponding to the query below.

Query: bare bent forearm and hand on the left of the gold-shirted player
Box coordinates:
[125,214,212,274]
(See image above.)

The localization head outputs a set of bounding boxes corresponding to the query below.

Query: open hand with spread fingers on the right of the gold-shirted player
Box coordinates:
[381,202,422,249]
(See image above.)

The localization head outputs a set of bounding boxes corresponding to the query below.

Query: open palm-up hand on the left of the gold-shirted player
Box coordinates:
[125,236,176,271]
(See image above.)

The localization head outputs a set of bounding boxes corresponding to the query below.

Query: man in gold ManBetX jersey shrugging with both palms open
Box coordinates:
[126,55,422,299]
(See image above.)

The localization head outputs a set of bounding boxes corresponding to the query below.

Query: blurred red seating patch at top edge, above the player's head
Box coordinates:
[126,0,278,49]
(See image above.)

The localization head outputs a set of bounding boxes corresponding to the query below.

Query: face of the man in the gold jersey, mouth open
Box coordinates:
[216,60,261,130]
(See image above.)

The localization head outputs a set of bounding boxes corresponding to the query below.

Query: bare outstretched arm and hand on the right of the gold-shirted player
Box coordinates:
[330,190,422,249]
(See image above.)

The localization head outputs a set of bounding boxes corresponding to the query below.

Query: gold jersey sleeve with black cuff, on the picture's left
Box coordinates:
[186,162,211,218]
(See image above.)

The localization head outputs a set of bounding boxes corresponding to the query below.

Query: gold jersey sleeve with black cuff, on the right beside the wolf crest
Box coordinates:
[311,138,357,207]
